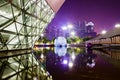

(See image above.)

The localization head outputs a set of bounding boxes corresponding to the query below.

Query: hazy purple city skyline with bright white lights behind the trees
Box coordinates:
[44,21,97,40]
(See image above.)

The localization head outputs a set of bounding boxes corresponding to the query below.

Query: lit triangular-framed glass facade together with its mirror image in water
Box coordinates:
[0,0,55,80]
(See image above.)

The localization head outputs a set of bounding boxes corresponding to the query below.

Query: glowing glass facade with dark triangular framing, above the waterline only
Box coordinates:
[0,0,55,50]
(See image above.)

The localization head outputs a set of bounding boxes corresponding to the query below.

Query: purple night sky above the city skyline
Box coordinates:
[49,0,120,33]
